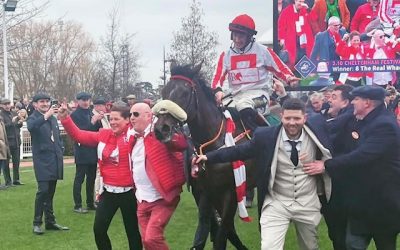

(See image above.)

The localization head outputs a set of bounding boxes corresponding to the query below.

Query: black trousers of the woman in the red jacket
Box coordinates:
[93,190,142,250]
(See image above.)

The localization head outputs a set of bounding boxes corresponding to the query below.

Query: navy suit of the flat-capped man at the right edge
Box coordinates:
[325,104,400,248]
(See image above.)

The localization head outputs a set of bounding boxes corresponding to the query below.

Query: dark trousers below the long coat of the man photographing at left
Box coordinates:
[33,180,57,226]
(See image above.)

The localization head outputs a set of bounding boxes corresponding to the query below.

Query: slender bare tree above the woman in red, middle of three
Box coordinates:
[95,5,140,100]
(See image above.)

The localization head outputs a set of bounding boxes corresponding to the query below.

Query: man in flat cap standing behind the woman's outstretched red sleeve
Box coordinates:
[71,92,103,214]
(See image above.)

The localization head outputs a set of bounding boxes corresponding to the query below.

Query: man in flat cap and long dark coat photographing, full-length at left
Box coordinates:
[27,93,68,235]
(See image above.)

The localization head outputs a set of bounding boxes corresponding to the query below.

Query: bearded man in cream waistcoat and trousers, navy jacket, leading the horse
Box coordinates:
[197,98,331,250]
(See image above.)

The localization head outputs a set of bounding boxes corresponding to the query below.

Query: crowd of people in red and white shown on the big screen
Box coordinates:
[277,0,400,89]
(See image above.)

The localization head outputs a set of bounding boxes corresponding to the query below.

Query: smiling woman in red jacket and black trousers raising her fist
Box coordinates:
[58,106,142,249]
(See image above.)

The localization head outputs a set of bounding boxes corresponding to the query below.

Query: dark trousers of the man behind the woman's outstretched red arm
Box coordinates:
[72,164,97,208]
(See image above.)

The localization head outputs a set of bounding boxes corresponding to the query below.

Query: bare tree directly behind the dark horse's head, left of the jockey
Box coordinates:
[169,0,218,80]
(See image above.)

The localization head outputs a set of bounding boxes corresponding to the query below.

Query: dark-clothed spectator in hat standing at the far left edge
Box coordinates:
[0,99,24,186]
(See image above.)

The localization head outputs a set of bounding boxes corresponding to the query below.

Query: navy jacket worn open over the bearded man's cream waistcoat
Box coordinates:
[206,116,331,219]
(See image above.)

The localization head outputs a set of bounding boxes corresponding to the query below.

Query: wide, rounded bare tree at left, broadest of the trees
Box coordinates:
[9,21,95,99]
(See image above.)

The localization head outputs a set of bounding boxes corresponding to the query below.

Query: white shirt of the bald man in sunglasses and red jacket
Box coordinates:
[132,125,162,202]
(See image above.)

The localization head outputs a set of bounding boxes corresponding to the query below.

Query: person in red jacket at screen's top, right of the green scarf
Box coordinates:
[350,0,380,33]
